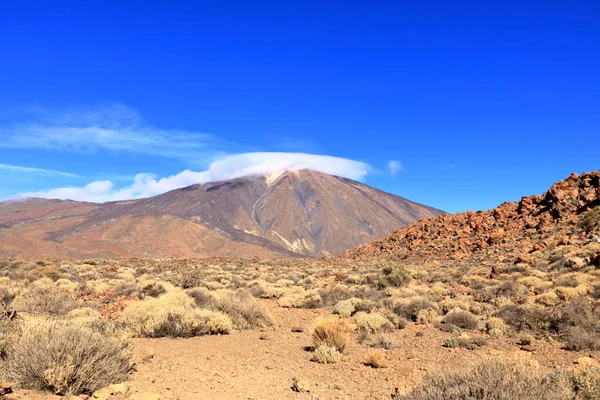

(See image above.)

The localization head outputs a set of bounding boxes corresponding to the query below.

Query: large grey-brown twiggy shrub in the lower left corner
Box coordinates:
[5,319,131,395]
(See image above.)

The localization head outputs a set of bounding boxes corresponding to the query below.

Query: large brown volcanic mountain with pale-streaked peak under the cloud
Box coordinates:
[0,170,441,258]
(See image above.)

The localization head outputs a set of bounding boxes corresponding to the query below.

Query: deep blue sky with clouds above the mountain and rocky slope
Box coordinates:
[0,0,600,212]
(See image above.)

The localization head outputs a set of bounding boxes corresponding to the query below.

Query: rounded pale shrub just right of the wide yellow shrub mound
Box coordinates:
[215,290,273,329]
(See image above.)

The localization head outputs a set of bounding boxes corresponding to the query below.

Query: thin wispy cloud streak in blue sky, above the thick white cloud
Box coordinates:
[0,104,227,159]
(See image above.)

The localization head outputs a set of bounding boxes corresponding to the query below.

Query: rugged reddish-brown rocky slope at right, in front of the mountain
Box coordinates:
[343,171,600,267]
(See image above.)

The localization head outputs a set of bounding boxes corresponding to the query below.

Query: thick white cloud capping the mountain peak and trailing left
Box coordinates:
[16,153,371,203]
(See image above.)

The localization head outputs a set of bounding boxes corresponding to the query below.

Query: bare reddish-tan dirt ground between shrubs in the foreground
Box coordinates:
[14,300,600,400]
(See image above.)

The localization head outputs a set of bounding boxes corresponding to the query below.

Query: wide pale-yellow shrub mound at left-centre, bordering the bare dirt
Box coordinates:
[121,291,233,337]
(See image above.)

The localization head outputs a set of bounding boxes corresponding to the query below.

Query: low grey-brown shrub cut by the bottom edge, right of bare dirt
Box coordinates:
[396,360,561,400]
